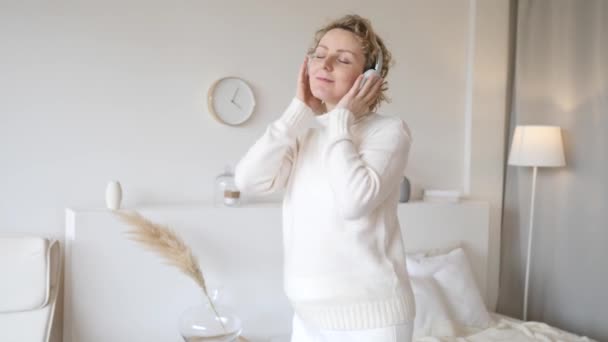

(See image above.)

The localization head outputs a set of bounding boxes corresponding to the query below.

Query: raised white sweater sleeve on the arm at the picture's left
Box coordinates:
[235,98,314,195]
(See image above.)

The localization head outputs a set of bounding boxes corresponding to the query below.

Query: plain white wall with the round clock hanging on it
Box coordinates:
[0,0,509,336]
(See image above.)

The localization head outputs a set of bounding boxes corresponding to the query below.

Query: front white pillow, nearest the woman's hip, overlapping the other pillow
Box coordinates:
[410,277,457,338]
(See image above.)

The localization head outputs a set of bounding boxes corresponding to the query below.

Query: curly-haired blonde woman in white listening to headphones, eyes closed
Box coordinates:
[235,15,415,342]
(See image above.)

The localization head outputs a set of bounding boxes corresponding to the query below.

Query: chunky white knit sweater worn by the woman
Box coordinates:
[235,99,415,330]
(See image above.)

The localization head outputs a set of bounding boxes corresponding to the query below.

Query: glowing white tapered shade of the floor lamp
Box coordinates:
[509,126,566,167]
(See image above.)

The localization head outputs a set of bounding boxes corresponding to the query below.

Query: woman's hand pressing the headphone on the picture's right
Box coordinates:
[336,74,384,118]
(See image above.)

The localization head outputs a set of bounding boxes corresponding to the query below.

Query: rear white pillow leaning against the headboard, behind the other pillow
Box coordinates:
[406,248,492,330]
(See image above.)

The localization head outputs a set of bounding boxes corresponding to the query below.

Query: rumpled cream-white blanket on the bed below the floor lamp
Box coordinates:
[416,314,594,342]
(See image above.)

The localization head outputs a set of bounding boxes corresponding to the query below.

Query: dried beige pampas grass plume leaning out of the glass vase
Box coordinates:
[114,211,225,329]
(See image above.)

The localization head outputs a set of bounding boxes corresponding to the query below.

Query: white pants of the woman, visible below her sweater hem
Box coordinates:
[291,315,414,342]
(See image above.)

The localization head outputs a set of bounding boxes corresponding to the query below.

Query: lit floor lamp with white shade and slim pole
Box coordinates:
[509,126,566,321]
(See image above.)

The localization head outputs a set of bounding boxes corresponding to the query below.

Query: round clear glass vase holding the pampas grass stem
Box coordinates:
[179,290,242,342]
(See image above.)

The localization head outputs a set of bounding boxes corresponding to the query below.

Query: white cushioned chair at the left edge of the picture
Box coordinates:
[0,235,62,342]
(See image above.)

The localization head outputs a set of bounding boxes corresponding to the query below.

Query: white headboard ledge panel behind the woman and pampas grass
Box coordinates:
[64,202,497,342]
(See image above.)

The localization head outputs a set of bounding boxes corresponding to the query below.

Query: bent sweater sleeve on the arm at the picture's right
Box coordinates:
[325,109,412,220]
